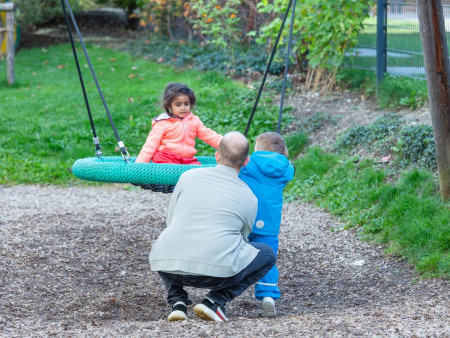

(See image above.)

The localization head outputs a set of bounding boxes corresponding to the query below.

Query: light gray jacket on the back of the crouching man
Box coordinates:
[150,164,258,277]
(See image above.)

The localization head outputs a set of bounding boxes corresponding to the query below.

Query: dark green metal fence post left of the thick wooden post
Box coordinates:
[377,0,387,89]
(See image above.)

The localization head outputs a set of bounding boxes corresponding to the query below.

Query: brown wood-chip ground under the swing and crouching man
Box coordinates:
[0,186,450,337]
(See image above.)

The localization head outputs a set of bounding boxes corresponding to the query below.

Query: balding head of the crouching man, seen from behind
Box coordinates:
[218,131,249,170]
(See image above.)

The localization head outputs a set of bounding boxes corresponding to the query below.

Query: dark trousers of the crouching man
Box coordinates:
[158,243,276,306]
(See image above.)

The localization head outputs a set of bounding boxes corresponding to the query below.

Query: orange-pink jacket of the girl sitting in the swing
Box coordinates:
[136,113,222,163]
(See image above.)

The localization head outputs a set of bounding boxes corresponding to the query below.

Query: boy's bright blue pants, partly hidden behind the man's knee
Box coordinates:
[248,233,281,300]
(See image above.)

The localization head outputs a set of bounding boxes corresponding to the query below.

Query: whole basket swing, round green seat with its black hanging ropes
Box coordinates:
[61,0,296,193]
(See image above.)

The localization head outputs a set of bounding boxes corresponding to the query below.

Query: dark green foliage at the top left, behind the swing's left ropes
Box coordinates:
[13,0,80,28]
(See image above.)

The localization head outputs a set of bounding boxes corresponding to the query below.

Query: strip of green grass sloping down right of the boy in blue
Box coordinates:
[287,148,450,278]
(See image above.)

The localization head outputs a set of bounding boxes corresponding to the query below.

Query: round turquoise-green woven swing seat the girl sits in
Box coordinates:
[72,156,216,185]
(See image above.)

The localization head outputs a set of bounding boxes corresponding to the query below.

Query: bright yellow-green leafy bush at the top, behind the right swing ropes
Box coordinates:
[254,0,373,84]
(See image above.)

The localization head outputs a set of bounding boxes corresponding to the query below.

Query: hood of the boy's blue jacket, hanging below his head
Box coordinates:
[250,151,292,179]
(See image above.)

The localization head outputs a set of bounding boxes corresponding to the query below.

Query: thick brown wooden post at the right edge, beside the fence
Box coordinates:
[417,0,450,201]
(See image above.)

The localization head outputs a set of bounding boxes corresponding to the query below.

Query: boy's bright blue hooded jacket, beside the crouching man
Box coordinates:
[239,151,294,236]
